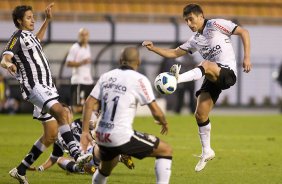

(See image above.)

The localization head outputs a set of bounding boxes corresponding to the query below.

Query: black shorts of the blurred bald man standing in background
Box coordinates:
[71,84,94,105]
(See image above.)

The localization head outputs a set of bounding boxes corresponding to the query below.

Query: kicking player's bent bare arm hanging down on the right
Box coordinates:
[233,26,252,73]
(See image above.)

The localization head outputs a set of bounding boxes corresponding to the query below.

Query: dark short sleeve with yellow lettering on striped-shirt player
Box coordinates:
[3,31,21,56]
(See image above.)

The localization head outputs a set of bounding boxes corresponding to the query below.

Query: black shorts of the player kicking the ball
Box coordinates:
[196,64,236,104]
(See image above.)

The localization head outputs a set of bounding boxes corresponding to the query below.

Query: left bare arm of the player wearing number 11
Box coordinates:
[80,95,100,152]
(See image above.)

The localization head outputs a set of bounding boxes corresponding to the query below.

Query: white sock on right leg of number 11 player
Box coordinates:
[155,157,172,184]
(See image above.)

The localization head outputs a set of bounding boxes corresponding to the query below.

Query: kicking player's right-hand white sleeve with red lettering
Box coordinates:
[212,19,238,36]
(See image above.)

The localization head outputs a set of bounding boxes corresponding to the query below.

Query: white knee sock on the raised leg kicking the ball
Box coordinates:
[177,66,205,83]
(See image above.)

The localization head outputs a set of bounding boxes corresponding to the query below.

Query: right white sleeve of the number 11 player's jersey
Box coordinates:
[136,77,155,105]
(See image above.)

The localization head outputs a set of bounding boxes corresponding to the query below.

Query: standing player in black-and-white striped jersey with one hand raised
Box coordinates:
[1,3,92,184]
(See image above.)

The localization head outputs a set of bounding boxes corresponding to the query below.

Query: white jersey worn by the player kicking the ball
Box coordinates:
[179,19,237,75]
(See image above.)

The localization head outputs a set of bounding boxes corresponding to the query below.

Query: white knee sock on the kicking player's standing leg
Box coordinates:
[198,119,211,153]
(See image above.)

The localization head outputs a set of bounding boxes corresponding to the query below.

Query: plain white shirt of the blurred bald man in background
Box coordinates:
[66,43,93,85]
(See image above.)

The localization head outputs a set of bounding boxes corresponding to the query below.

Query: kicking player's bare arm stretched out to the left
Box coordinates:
[142,41,186,58]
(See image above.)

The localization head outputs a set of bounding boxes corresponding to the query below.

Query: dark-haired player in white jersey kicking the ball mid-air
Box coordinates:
[143,4,251,172]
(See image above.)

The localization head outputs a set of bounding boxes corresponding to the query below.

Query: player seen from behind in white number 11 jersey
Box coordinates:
[80,47,172,184]
